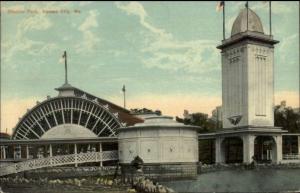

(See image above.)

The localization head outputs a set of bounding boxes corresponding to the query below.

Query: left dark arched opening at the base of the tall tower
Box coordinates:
[221,137,243,163]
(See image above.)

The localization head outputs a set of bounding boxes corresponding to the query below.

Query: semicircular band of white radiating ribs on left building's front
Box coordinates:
[12,97,122,139]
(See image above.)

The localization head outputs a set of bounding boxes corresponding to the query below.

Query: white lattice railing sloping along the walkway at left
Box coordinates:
[0,151,118,176]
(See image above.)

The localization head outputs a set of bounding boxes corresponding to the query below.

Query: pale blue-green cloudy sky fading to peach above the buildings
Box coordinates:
[1,1,299,133]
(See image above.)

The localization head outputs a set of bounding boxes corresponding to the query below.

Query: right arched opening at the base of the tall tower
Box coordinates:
[254,136,276,163]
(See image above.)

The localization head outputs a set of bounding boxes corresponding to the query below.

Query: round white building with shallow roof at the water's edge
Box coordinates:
[118,115,198,178]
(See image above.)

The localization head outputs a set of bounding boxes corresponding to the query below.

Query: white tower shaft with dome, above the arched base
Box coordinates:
[218,8,278,129]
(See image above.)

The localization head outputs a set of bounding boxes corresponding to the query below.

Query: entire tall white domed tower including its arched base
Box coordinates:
[216,7,283,163]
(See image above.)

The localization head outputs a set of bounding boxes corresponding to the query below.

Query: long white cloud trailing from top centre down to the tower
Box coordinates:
[115,2,220,73]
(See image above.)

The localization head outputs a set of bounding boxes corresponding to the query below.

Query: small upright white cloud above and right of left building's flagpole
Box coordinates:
[76,10,100,53]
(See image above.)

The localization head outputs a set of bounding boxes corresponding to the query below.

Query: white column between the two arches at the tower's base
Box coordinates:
[243,134,255,164]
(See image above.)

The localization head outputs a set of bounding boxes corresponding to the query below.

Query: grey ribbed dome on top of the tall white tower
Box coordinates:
[231,8,264,36]
